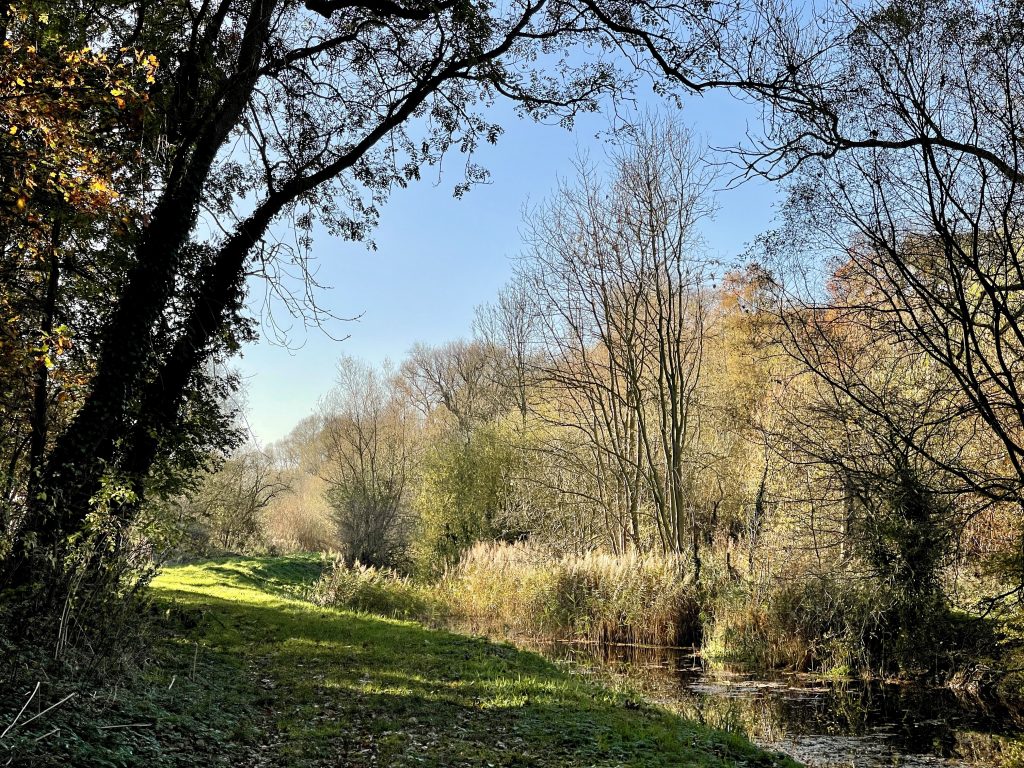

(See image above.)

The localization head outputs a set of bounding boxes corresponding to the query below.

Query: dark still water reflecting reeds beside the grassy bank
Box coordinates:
[538,643,1024,768]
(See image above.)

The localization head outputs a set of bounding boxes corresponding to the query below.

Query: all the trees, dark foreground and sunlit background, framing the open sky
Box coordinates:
[0,0,1024,684]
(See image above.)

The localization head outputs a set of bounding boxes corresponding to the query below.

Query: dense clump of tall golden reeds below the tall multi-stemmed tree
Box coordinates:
[443,543,699,645]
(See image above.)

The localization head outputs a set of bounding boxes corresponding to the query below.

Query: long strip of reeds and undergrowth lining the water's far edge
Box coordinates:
[312,543,1007,684]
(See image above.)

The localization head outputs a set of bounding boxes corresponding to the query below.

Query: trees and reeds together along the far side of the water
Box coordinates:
[267,112,1022,690]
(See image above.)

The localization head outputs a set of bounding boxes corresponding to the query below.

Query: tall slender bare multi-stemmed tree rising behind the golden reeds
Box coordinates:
[522,121,711,578]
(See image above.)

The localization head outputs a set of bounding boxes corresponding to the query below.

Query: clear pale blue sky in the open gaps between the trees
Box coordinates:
[238,92,776,443]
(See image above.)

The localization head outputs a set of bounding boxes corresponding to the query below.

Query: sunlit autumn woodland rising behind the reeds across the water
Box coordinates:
[193,112,1019,667]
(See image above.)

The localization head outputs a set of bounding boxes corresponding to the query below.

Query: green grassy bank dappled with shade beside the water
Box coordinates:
[0,558,792,768]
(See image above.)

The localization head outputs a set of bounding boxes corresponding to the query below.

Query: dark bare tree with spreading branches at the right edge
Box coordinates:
[732,2,1024,592]
